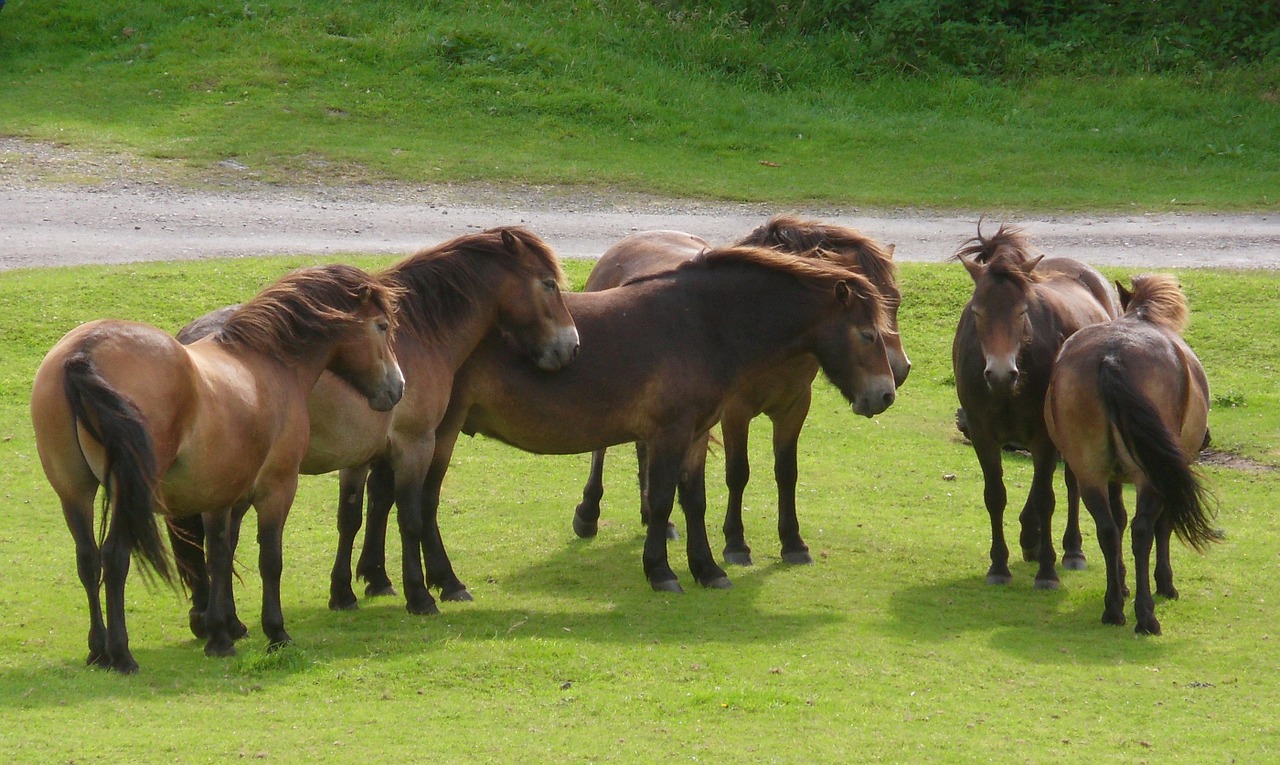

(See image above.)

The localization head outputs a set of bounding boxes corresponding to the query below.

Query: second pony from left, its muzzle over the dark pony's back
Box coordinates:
[175,226,577,628]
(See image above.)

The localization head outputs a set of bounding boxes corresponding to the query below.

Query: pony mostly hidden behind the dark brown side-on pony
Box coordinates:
[573,215,911,565]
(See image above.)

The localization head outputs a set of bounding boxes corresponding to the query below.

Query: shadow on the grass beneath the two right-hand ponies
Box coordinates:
[878,563,1176,665]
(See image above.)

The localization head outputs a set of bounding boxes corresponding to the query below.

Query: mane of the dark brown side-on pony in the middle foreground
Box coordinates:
[691,244,890,331]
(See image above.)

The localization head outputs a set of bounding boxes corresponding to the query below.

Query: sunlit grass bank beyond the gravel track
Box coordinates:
[0,0,1280,210]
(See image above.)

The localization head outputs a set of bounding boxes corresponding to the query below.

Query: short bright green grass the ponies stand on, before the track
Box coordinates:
[0,258,1280,764]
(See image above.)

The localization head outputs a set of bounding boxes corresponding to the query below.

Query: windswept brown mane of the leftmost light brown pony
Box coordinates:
[218,265,399,358]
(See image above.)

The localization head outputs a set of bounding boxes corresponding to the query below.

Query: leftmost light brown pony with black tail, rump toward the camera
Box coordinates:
[31,266,404,673]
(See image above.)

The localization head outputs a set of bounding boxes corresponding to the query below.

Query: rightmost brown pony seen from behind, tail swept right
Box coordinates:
[1044,275,1221,635]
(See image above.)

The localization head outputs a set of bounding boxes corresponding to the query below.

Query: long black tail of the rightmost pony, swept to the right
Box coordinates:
[1098,356,1222,551]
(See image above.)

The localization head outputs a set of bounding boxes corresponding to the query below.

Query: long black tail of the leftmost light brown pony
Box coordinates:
[64,349,173,585]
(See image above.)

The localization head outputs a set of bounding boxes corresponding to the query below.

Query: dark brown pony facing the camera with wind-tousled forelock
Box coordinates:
[951,225,1119,588]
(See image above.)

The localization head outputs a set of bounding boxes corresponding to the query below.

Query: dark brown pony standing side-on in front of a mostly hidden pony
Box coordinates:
[401,247,893,592]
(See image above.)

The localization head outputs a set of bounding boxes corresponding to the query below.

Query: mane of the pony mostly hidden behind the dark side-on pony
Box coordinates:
[737,215,897,298]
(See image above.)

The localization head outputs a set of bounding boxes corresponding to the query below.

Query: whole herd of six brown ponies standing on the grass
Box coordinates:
[31,216,1216,673]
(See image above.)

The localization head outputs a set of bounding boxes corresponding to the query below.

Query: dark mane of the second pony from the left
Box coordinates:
[380,226,564,339]
